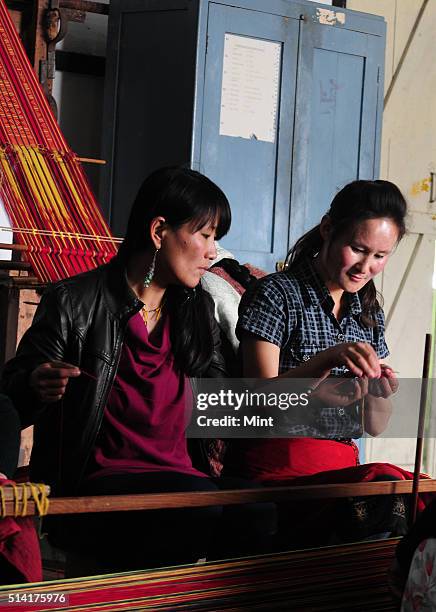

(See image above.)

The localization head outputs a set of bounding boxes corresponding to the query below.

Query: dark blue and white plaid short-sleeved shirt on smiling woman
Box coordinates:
[236,260,389,439]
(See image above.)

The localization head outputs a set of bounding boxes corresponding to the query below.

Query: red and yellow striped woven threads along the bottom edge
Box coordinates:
[0,539,398,612]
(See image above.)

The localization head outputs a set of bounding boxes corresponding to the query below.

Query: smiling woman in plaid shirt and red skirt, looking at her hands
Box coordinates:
[226,180,418,544]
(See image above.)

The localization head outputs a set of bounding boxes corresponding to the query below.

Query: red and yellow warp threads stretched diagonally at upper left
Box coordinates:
[0,0,117,282]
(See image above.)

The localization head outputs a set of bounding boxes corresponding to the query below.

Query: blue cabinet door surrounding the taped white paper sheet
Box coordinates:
[198,3,299,270]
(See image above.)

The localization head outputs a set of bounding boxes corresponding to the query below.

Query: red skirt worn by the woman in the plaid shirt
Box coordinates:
[226,438,432,549]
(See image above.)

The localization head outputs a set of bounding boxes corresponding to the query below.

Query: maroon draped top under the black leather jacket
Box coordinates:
[88,313,205,478]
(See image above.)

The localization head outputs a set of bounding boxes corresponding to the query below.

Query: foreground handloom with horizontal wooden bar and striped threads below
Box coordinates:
[0,479,436,610]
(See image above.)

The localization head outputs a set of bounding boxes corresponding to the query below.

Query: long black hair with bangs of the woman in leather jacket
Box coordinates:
[118,167,231,376]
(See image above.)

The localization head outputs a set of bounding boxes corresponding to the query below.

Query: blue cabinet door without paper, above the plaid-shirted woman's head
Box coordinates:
[289,19,385,245]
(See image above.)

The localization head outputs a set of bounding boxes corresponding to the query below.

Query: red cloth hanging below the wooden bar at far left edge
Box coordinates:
[0,479,42,584]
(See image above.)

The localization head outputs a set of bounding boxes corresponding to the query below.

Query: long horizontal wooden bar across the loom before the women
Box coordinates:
[2,478,436,516]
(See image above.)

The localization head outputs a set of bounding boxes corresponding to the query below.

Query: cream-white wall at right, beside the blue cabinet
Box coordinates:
[347,0,436,473]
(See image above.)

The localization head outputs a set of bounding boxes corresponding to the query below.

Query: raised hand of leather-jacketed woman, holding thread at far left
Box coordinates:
[30,361,81,404]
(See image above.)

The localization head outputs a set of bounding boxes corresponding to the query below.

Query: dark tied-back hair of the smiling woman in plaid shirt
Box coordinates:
[286,180,407,326]
